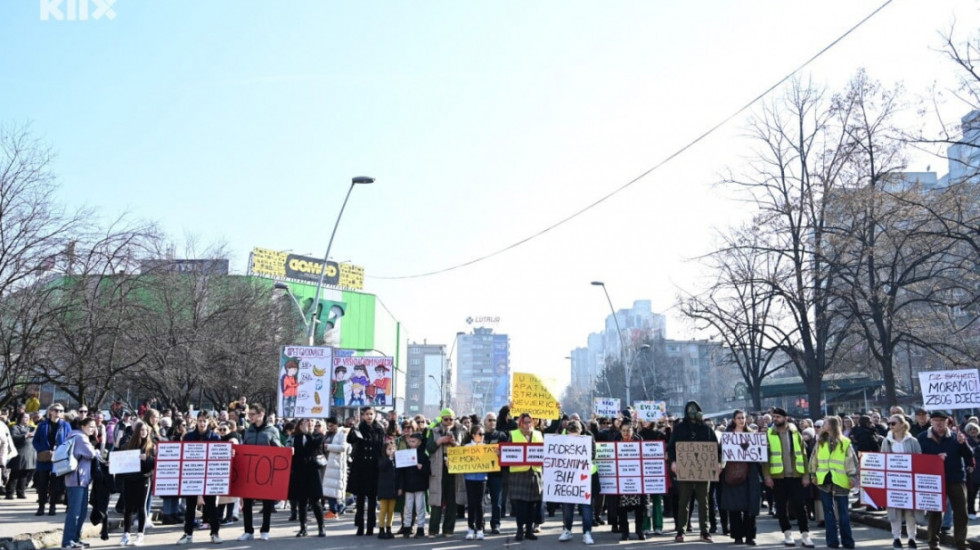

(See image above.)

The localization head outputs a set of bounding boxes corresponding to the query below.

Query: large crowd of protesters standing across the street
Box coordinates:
[0,397,980,549]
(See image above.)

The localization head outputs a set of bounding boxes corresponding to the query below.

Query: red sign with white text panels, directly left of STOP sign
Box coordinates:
[152,441,234,496]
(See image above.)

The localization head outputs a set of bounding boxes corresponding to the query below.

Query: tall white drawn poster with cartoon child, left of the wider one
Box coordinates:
[276,346,333,418]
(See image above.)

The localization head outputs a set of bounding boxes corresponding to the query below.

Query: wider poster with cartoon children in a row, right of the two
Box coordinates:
[330,356,395,407]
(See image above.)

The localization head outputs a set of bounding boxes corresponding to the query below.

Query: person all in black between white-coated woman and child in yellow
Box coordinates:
[347,406,385,536]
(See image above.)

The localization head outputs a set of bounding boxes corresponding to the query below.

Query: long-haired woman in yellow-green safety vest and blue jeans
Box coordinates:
[810,416,856,548]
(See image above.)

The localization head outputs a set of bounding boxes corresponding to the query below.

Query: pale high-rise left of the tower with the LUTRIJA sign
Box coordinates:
[404,341,448,418]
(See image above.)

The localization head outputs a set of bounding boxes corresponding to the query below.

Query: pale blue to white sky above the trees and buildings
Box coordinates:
[0,0,978,396]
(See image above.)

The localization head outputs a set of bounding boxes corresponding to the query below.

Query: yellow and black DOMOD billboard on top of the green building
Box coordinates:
[248,247,364,290]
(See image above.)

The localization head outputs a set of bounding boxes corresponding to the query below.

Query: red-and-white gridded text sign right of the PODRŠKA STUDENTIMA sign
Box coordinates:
[595,441,670,495]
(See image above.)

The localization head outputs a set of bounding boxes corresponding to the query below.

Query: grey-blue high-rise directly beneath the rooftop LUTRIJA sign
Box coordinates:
[453,327,510,414]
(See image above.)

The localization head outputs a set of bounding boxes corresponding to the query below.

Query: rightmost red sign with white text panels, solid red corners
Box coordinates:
[858,453,946,512]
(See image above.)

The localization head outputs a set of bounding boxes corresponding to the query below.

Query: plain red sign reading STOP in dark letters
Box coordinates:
[227,445,293,500]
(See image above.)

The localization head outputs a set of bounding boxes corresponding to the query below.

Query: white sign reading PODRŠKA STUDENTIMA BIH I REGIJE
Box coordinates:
[542,434,592,504]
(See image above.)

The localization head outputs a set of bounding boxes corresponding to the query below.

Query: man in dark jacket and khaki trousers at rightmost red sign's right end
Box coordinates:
[919,411,973,549]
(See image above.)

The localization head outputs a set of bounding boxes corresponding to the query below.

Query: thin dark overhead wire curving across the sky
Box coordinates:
[368,0,894,280]
